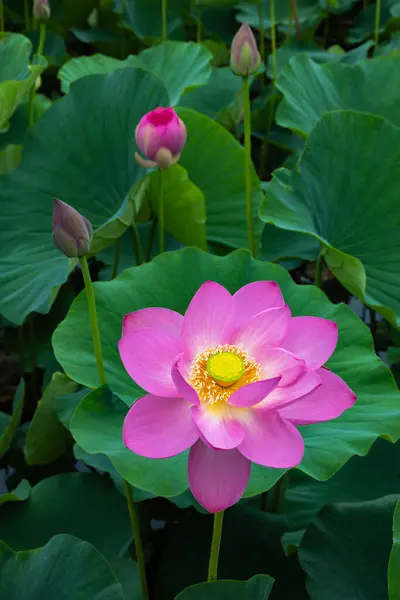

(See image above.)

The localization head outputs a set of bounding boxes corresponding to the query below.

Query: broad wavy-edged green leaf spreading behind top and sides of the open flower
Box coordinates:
[53,248,400,489]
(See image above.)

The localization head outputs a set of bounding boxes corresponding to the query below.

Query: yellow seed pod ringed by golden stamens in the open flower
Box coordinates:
[189,344,261,404]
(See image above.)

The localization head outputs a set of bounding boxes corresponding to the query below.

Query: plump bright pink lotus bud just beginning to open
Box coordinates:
[135,107,186,169]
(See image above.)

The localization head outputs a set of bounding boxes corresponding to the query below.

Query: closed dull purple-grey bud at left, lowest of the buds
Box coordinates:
[53,198,93,258]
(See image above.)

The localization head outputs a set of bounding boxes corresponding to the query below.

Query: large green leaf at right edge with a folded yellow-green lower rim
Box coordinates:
[260,112,400,324]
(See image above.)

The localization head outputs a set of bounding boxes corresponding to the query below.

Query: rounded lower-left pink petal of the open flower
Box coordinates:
[122,395,199,458]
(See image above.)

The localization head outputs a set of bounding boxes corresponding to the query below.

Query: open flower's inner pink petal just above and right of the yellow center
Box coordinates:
[230,305,290,363]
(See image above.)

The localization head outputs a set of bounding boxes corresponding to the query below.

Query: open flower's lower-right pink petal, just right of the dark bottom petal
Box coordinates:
[238,409,304,469]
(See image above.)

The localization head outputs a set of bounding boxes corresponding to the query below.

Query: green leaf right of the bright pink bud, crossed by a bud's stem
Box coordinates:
[178,108,263,248]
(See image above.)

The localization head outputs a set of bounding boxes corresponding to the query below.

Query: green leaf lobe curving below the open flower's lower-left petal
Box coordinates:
[71,387,188,497]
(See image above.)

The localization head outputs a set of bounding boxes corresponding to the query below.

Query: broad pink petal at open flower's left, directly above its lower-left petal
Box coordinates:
[118,329,182,397]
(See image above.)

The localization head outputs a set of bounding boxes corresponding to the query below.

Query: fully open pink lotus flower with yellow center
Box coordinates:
[119,281,356,513]
